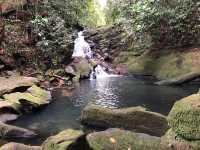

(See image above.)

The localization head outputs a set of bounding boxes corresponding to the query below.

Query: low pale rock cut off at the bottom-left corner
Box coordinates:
[0,142,42,150]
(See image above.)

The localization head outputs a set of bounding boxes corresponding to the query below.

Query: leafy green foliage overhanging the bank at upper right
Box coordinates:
[107,0,200,47]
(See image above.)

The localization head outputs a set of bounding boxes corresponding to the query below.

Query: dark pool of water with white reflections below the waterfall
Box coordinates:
[10,77,198,144]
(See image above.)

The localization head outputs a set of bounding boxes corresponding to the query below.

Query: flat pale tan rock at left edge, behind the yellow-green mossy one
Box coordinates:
[0,76,39,96]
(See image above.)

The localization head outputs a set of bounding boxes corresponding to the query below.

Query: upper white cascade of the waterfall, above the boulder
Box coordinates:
[72,31,93,59]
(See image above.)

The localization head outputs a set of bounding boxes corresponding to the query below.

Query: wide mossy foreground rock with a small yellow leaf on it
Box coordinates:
[87,129,167,150]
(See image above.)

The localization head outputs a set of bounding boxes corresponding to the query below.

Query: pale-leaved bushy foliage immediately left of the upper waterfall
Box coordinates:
[30,11,73,69]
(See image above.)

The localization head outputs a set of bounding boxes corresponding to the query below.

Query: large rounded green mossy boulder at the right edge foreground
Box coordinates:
[168,94,200,140]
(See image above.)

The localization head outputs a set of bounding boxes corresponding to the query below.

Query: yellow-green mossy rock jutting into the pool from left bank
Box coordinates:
[3,85,51,107]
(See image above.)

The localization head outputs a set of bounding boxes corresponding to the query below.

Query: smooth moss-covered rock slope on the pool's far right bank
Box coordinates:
[115,51,200,79]
